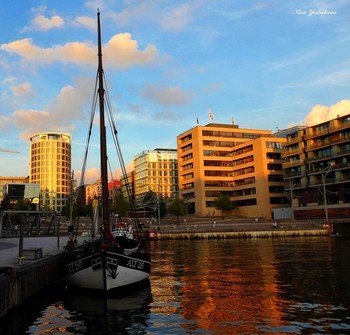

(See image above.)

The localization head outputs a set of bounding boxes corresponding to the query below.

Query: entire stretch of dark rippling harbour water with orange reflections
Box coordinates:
[0,237,350,335]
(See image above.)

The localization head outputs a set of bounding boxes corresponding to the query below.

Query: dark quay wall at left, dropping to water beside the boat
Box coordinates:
[0,254,62,318]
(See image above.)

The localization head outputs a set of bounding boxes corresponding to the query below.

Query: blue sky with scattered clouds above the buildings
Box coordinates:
[0,0,350,184]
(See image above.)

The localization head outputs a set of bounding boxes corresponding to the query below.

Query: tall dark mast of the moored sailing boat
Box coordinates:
[97,11,110,228]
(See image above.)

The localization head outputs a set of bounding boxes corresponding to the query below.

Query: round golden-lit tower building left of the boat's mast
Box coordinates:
[30,132,72,212]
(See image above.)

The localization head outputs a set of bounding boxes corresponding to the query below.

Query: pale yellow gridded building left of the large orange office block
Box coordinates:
[133,148,178,200]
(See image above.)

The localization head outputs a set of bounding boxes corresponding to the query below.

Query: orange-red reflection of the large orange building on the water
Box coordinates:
[172,243,284,334]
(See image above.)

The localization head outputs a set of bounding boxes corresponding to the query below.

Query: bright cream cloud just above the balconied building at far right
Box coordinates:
[305,100,350,127]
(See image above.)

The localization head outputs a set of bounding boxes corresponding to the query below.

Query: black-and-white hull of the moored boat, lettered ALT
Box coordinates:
[64,250,151,292]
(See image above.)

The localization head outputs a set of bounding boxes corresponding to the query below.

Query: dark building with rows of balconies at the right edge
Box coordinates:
[283,114,350,221]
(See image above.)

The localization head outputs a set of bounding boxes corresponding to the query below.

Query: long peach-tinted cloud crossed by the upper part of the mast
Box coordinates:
[0,33,157,68]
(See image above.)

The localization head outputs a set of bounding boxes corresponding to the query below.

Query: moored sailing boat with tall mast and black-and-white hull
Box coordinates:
[64,11,151,292]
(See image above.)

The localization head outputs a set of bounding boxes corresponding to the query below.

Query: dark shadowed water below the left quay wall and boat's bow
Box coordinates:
[0,285,152,335]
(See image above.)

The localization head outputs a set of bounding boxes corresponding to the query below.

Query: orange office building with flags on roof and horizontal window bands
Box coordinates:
[177,123,288,219]
